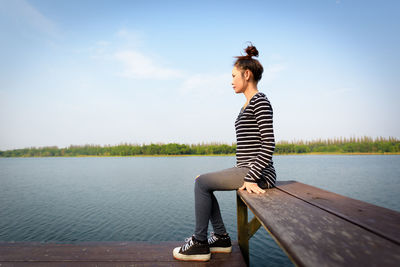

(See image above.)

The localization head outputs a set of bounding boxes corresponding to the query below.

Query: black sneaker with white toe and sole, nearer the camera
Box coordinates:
[172,235,211,261]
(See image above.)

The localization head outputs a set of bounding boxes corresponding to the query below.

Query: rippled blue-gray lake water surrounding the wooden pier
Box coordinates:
[0,155,400,266]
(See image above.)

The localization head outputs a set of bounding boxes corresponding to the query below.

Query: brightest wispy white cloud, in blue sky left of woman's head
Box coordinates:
[114,50,182,79]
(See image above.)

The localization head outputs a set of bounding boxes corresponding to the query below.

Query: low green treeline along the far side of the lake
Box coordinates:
[0,137,400,157]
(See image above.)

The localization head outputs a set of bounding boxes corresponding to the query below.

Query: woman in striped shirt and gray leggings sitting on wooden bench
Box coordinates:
[173,45,276,261]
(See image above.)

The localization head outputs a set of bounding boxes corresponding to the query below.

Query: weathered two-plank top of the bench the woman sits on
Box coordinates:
[238,181,400,266]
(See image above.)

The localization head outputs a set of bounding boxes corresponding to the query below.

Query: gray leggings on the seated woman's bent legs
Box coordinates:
[194,167,249,241]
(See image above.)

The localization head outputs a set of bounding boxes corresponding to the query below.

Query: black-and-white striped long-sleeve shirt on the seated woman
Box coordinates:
[235,92,276,188]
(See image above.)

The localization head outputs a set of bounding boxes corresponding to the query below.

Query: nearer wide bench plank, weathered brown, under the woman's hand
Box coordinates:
[238,188,400,266]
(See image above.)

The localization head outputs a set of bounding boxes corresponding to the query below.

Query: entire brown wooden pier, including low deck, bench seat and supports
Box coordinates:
[0,181,400,267]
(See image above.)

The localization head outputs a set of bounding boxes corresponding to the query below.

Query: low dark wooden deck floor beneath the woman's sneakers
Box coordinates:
[0,241,246,267]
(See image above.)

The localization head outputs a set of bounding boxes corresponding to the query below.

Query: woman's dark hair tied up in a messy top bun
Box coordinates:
[233,43,264,82]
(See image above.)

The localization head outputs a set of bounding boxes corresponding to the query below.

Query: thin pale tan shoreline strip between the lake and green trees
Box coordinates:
[0,152,400,158]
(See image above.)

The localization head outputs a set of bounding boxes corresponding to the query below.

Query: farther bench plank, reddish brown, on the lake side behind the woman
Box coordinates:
[277,181,400,245]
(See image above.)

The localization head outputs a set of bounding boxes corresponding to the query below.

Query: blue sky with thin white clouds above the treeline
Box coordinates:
[0,0,400,150]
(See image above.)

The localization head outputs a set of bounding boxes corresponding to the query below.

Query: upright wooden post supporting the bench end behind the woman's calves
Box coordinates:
[236,194,250,266]
